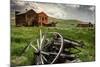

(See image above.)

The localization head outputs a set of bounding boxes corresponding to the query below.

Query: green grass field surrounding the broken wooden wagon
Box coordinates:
[11,20,95,65]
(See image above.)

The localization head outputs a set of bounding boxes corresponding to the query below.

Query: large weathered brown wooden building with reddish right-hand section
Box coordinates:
[15,9,53,26]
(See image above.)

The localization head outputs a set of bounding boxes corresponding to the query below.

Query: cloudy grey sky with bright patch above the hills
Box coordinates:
[11,0,95,23]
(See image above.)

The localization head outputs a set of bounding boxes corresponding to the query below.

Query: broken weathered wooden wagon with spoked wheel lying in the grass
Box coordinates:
[20,30,84,65]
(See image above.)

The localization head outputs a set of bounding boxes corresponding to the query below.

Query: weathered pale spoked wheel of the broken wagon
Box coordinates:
[25,30,63,65]
